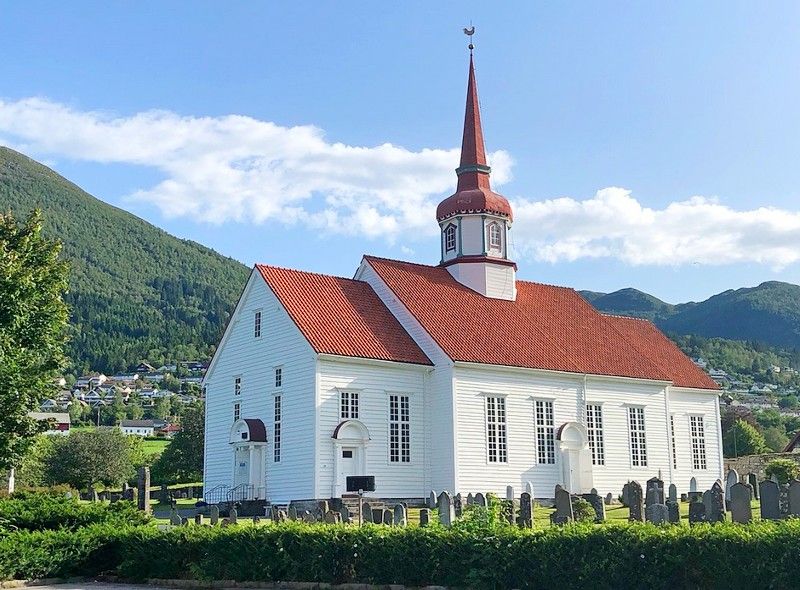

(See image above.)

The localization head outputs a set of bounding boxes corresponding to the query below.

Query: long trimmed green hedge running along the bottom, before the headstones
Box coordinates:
[0,520,800,590]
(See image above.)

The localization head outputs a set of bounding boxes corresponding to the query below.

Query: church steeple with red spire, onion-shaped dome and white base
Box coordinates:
[436,46,516,300]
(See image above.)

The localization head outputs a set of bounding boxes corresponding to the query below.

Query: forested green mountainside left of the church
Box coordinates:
[0,146,248,372]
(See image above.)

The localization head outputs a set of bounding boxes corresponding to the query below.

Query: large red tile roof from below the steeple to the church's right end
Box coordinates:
[365,256,716,389]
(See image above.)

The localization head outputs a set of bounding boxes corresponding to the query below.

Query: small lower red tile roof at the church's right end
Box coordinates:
[605,315,719,389]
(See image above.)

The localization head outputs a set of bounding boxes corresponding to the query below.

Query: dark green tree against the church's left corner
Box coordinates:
[153,403,205,483]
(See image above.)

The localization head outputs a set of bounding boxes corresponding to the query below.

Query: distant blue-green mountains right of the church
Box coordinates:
[581,281,800,349]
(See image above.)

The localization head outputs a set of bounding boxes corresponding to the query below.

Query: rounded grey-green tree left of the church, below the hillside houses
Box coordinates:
[46,428,136,489]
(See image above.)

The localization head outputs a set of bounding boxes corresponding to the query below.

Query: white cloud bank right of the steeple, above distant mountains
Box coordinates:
[514,187,800,268]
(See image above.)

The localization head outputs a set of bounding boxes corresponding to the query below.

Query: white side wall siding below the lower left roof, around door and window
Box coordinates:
[316,357,428,498]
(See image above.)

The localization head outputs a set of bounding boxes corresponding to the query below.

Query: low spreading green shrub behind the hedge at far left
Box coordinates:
[0,492,149,531]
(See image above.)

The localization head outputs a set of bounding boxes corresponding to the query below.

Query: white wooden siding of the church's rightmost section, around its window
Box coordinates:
[669,387,723,493]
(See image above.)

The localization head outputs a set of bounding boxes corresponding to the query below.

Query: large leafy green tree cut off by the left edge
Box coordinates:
[0,210,69,470]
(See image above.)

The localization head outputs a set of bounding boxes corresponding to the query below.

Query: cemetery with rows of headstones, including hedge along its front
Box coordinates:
[0,470,800,588]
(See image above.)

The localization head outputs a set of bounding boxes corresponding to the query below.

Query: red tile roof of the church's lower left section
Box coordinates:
[256,264,432,365]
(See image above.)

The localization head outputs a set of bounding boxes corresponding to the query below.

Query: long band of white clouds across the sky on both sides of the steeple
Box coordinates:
[0,98,800,268]
